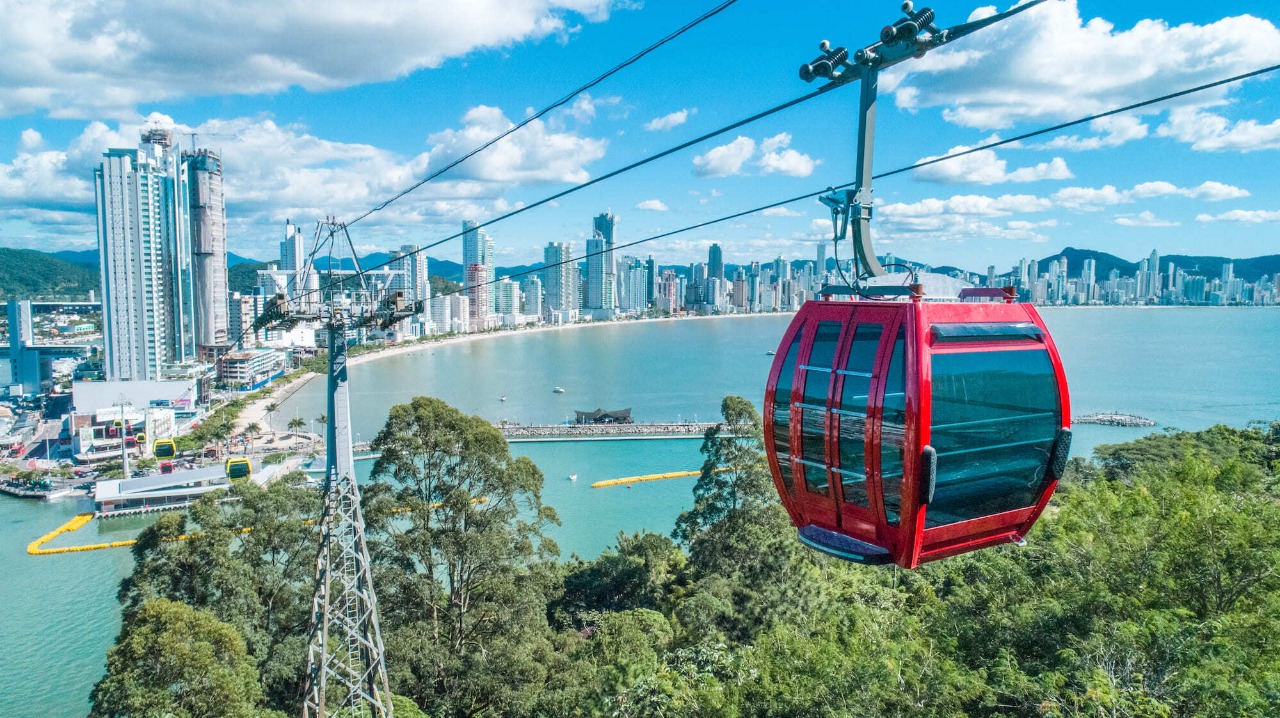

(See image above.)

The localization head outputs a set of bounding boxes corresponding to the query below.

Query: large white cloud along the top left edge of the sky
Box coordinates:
[0,0,612,118]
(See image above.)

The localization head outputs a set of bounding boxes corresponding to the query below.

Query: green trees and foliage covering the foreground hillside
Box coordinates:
[95,397,1280,718]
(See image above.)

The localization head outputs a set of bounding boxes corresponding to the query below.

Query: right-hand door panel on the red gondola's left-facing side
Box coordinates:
[831,302,902,548]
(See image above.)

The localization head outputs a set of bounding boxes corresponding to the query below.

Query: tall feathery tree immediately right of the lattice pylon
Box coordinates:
[367,397,559,715]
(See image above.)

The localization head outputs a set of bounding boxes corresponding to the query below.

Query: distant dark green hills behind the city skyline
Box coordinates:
[0,247,1280,299]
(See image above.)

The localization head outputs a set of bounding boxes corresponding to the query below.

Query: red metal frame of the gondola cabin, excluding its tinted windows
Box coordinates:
[764,297,1071,568]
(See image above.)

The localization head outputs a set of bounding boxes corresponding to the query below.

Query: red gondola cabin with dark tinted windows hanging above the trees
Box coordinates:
[764,282,1071,568]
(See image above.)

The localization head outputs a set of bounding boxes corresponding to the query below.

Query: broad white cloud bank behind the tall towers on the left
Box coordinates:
[0,108,604,252]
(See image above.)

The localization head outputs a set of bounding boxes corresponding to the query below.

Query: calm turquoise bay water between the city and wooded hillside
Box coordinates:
[0,308,1280,718]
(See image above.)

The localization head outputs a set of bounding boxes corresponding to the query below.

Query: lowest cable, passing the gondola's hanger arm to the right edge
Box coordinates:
[436,60,1280,297]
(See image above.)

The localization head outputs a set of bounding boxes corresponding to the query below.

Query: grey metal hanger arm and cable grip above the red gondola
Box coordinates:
[800,0,1044,283]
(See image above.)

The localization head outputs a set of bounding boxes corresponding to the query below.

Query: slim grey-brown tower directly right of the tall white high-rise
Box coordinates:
[178,150,229,353]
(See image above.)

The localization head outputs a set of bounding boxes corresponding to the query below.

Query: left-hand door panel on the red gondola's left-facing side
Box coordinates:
[791,302,852,529]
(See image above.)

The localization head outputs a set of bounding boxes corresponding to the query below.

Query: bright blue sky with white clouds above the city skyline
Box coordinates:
[0,0,1280,270]
